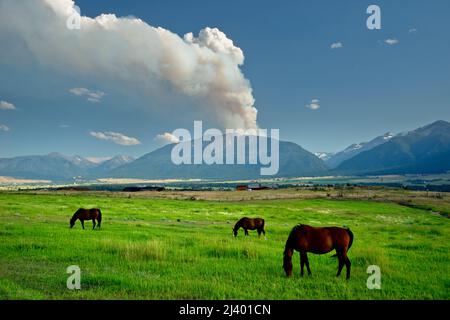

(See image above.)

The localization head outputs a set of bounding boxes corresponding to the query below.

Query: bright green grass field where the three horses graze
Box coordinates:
[0,193,450,299]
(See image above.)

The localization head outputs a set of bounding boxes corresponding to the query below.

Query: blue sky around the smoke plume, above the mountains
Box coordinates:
[0,0,450,157]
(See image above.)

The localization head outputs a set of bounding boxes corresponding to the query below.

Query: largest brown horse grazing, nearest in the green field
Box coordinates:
[283,224,353,279]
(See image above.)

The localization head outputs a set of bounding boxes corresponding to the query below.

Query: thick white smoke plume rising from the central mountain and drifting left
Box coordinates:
[0,0,257,128]
